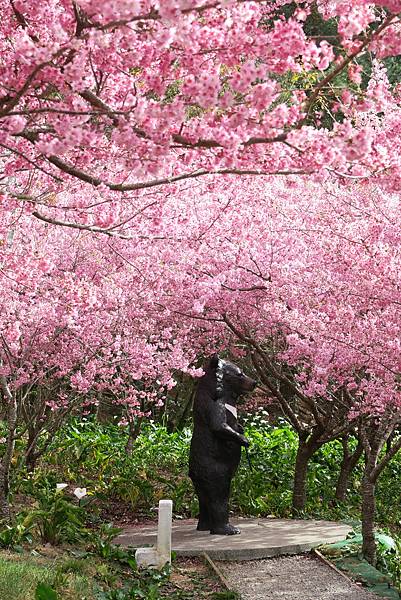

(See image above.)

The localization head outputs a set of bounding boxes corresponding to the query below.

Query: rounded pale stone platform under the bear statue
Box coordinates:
[114,519,351,560]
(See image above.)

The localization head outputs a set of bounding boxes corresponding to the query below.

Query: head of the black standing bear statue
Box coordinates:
[208,354,257,400]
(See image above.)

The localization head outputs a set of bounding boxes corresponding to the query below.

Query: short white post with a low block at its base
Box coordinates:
[135,500,173,569]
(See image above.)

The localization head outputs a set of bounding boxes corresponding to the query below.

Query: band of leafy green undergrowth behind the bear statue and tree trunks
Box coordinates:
[19,418,401,525]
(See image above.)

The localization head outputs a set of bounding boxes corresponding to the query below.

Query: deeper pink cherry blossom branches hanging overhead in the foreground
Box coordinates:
[0,0,401,236]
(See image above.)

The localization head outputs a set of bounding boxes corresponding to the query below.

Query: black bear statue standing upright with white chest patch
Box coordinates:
[189,355,256,535]
